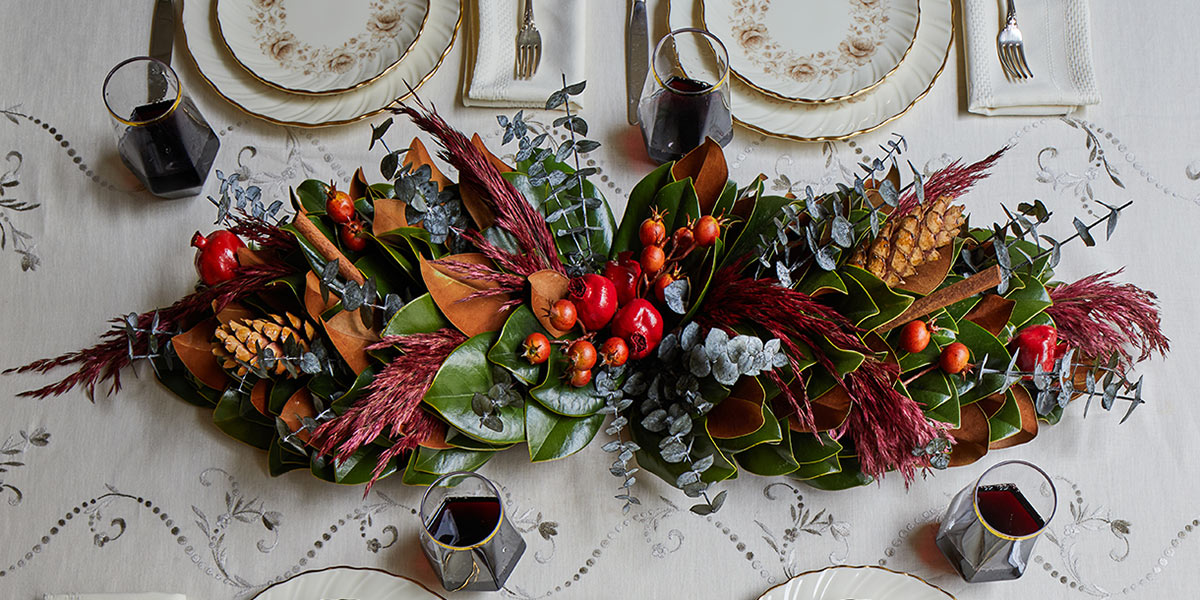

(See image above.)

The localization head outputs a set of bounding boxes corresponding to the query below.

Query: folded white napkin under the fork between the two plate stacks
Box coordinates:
[462,0,587,108]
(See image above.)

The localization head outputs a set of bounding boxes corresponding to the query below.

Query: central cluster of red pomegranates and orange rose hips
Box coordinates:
[513,212,721,388]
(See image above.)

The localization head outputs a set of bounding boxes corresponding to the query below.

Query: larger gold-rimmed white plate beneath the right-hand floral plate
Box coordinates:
[667,0,954,142]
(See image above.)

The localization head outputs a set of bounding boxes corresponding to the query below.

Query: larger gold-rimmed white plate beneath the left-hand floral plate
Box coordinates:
[184,0,462,127]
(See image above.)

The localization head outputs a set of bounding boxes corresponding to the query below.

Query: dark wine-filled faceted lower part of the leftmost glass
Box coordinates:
[118,97,221,198]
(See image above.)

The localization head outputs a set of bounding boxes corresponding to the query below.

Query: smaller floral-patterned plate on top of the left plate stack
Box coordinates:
[216,0,430,95]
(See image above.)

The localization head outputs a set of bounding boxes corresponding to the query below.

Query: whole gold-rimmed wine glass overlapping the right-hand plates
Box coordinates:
[637,28,733,163]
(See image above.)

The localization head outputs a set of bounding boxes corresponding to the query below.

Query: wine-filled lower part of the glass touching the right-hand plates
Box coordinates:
[640,76,733,163]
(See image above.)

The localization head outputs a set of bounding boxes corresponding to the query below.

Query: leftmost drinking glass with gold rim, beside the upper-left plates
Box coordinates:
[103,56,221,198]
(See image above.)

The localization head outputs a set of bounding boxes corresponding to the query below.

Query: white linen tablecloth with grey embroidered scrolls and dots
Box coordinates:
[0,0,1200,600]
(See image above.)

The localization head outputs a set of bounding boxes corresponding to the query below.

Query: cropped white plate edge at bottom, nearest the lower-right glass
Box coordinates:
[758,565,954,600]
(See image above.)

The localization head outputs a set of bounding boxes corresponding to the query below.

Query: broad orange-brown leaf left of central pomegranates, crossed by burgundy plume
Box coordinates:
[419,252,515,337]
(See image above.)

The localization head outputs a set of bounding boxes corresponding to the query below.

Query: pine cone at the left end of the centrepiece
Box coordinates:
[212,312,316,377]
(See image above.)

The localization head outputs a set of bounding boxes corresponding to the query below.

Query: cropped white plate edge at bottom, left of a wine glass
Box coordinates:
[254,566,444,600]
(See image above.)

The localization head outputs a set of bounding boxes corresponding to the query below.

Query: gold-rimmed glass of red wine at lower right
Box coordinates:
[937,461,1058,582]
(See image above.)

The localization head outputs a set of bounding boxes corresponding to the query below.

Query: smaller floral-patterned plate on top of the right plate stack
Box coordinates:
[701,0,920,102]
